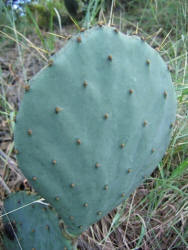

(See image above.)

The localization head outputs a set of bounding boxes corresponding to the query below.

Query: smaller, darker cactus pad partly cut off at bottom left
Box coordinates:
[3,191,75,250]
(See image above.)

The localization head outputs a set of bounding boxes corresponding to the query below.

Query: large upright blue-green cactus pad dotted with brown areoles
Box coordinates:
[15,25,176,235]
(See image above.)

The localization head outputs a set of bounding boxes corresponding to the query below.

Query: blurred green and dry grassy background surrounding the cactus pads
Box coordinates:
[0,0,188,250]
